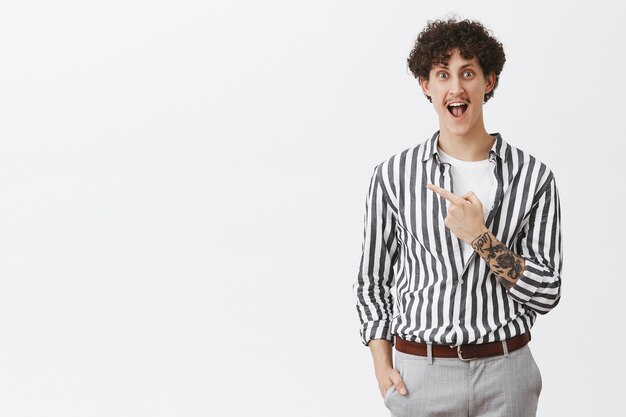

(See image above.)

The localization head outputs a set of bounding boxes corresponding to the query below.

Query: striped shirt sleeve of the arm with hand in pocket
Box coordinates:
[353,166,397,346]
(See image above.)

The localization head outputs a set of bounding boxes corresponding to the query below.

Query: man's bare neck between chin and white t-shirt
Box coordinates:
[438,128,495,161]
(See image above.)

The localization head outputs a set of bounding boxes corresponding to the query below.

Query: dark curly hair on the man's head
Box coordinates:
[407,18,506,102]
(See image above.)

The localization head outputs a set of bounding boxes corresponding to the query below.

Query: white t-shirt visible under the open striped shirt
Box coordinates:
[438,149,497,262]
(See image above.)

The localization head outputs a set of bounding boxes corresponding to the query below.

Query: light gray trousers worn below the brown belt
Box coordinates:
[385,345,541,417]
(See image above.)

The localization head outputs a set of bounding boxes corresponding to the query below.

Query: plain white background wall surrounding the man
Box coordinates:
[0,0,626,417]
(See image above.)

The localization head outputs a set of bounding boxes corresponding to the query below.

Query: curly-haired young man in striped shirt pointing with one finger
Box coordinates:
[354,19,562,417]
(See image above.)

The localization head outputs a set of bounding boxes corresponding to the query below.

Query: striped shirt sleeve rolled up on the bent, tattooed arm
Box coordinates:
[508,175,562,314]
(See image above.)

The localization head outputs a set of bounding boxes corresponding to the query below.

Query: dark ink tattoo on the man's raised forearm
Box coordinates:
[472,232,523,281]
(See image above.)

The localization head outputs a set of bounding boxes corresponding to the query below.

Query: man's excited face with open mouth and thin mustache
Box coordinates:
[420,50,496,138]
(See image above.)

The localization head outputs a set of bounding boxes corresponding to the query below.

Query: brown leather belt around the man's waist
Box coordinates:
[396,333,530,361]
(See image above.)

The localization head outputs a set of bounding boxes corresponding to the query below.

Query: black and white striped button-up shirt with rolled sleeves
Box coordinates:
[353,132,562,346]
